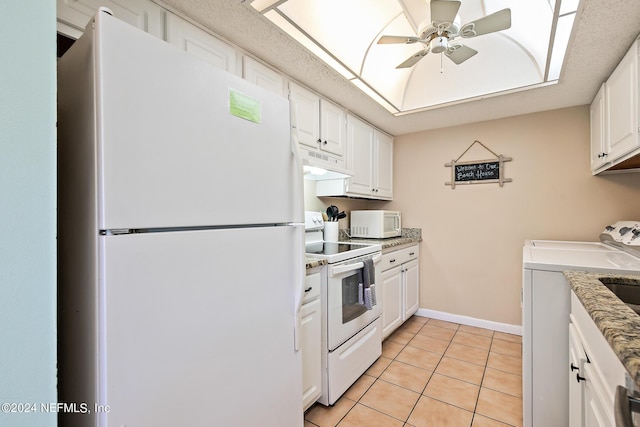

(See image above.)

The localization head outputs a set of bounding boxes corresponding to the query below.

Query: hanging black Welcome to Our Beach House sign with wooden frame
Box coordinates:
[445,140,512,189]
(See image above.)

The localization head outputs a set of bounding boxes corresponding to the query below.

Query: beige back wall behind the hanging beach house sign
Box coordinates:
[387,106,640,325]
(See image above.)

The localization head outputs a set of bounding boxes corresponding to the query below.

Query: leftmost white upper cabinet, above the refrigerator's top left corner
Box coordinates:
[56,0,165,39]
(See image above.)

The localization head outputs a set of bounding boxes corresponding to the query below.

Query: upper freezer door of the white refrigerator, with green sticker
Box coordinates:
[96,13,302,229]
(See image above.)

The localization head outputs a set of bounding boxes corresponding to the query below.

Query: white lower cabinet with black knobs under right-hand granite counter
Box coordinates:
[567,291,627,427]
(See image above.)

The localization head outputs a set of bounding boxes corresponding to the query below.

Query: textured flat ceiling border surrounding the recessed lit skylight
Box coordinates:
[156,0,640,135]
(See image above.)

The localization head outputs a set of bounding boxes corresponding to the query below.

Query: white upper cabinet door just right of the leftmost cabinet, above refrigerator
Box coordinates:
[167,13,240,75]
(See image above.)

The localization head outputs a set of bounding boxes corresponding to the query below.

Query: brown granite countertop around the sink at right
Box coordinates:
[564,271,640,388]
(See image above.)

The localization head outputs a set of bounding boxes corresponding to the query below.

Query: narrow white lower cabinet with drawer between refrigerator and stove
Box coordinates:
[300,269,322,411]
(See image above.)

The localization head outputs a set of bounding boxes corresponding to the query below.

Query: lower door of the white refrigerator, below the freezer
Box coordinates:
[99,227,303,427]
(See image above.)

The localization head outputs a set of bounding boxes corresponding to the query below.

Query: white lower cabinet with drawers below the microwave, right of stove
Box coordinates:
[376,245,420,338]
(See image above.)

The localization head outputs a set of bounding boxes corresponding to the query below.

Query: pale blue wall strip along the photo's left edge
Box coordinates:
[0,0,57,427]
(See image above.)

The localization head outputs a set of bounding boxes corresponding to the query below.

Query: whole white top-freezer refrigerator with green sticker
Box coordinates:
[58,10,304,427]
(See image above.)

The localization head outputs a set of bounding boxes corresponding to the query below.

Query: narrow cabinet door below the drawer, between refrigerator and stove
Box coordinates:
[300,299,322,410]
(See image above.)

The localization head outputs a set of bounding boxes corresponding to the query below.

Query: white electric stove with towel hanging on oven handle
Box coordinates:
[305,212,382,405]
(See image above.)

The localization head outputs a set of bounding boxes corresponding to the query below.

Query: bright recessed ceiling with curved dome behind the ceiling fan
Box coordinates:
[251,0,578,114]
